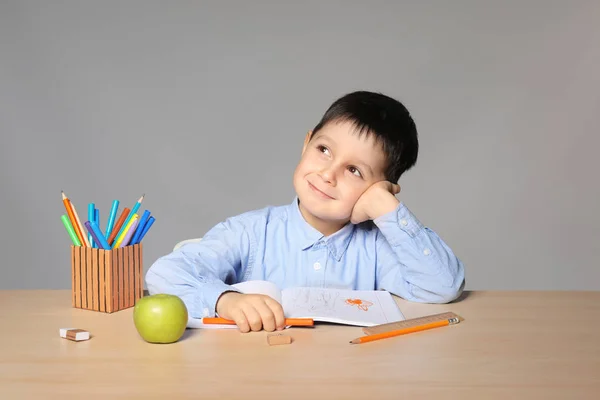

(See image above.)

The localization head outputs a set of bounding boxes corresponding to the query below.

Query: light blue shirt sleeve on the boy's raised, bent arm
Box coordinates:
[373,203,465,303]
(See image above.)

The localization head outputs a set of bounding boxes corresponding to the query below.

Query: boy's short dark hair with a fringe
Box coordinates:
[311,91,419,182]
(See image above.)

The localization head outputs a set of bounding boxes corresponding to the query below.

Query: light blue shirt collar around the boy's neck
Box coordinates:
[288,196,355,261]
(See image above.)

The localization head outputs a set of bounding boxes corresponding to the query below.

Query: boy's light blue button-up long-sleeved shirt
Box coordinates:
[146,198,465,318]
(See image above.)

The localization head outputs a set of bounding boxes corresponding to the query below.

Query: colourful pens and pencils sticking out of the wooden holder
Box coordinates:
[61,191,155,250]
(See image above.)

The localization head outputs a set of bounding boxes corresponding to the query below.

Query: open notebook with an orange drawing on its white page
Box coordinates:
[188,281,404,329]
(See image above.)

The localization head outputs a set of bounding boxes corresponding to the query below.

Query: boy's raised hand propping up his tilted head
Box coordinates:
[350,181,400,224]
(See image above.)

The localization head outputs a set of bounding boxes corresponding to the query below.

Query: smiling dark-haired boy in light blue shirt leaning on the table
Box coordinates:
[146,92,464,332]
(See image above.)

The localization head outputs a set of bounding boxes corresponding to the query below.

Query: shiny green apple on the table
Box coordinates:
[133,294,188,343]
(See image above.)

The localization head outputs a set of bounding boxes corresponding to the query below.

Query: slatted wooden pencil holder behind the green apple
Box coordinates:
[71,243,144,313]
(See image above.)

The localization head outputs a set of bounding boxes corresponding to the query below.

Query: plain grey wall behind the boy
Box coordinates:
[0,0,600,290]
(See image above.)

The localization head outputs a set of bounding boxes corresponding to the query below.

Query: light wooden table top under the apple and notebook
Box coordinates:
[0,290,600,400]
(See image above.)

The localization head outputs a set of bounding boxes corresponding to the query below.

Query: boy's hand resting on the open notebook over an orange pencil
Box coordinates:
[216,292,285,333]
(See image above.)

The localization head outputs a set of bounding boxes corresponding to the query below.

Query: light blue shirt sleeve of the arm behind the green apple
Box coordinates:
[146,219,252,318]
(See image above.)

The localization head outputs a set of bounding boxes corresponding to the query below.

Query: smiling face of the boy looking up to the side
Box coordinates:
[294,121,386,229]
